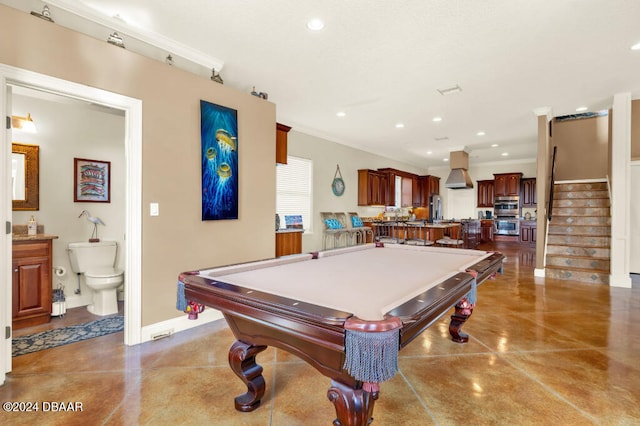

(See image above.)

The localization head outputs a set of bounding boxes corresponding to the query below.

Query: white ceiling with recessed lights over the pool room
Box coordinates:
[5,0,640,168]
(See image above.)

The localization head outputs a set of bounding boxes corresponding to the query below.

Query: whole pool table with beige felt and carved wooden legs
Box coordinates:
[178,243,504,425]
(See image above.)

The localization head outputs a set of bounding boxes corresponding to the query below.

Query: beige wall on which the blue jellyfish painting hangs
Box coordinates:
[0,6,275,325]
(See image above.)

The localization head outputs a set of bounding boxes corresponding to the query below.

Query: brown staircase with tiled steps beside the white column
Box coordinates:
[545,182,611,284]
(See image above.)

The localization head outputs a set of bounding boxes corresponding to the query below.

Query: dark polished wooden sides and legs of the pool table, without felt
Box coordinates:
[180,248,504,426]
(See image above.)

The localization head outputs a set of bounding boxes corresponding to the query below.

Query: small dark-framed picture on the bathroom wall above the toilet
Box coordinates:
[73,158,111,203]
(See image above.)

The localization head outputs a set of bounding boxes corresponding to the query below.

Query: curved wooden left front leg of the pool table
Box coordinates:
[229,340,267,412]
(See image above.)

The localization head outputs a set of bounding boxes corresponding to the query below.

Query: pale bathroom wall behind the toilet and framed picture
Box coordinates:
[12,94,125,308]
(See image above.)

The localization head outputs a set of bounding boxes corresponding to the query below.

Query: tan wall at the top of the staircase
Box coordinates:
[553,116,609,180]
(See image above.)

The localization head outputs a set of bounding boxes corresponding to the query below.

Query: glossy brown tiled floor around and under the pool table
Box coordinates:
[0,244,640,426]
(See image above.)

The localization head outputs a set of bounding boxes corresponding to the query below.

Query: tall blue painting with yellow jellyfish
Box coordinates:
[200,100,238,220]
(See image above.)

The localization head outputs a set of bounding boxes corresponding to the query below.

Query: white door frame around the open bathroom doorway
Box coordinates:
[0,64,142,385]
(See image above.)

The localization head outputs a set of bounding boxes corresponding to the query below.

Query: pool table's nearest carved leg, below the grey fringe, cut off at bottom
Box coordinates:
[327,380,378,426]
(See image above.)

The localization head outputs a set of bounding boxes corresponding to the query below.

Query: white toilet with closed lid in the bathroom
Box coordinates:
[68,241,124,315]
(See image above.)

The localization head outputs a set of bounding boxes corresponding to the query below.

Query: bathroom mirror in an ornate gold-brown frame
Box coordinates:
[11,143,40,210]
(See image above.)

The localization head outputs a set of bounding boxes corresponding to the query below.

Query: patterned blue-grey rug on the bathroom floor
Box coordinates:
[12,316,124,356]
